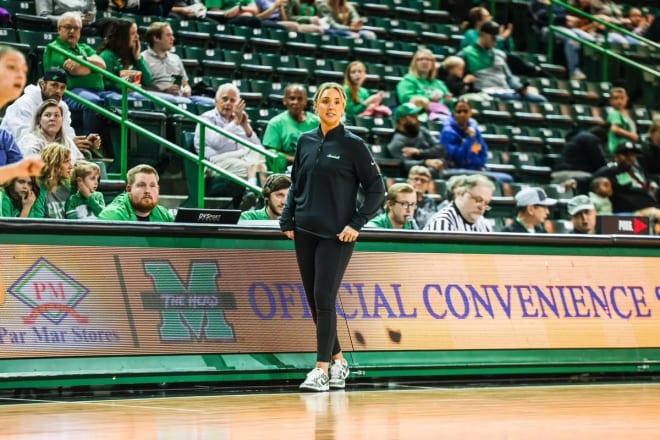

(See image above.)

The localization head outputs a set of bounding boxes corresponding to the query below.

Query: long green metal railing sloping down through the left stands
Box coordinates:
[50,46,277,207]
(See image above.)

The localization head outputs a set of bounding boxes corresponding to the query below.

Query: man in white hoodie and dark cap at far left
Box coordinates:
[0,67,101,156]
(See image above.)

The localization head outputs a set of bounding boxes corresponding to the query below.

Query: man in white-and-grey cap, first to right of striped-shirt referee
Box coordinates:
[502,187,557,234]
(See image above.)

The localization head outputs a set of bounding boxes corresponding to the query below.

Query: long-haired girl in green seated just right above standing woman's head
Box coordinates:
[344,61,392,117]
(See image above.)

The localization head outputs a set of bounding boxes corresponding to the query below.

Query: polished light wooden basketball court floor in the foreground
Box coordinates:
[0,384,660,440]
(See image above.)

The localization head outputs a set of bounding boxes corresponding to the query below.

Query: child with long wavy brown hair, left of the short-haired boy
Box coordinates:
[37,143,73,219]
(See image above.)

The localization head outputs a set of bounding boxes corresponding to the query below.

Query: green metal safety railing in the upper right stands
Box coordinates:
[548,0,660,81]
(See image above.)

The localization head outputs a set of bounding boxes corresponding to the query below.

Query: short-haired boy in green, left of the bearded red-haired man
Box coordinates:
[64,160,105,220]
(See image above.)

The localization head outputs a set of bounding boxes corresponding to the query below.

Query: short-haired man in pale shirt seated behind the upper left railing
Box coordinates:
[142,21,214,105]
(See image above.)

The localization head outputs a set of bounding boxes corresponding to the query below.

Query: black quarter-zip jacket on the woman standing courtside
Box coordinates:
[280,124,385,238]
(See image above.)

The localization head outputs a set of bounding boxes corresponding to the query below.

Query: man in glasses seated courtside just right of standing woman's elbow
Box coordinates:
[365,183,419,229]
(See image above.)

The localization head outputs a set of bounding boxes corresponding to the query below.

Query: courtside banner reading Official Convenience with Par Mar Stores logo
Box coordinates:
[0,245,660,358]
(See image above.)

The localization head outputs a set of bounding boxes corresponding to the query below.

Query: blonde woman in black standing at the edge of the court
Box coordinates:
[280,83,385,391]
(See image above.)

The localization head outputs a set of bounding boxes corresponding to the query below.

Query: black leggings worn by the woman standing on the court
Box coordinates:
[295,231,355,362]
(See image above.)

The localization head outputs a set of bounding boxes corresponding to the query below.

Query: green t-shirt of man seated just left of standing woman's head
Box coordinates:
[261,111,319,156]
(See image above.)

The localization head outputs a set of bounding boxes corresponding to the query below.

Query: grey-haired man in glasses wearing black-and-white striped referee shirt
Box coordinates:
[424,174,495,232]
